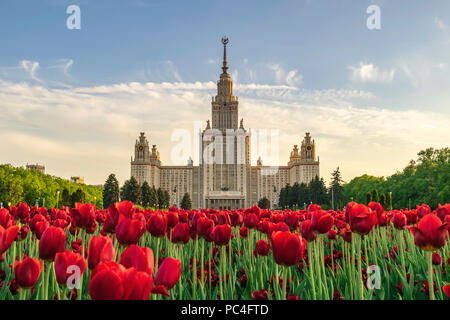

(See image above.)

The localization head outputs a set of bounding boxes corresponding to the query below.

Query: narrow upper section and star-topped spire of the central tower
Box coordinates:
[211,37,238,133]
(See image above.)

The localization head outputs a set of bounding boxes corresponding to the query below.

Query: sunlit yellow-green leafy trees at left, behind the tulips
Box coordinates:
[0,164,102,208]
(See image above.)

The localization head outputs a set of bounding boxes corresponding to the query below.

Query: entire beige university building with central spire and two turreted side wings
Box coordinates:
[131,38,319,210]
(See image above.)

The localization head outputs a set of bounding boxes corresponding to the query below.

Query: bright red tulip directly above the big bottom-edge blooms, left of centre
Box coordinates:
[119,244,155,274]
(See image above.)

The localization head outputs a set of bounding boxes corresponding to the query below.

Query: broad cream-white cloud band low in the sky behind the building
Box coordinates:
[0,76,450,184]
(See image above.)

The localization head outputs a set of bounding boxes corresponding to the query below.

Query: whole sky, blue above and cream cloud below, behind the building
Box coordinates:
[0,0,450,184]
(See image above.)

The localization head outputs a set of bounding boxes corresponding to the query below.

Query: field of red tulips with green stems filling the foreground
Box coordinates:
[0,201,450,300]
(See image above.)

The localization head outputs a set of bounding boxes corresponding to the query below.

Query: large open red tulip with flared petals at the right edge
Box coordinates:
[409,213,449,251]
